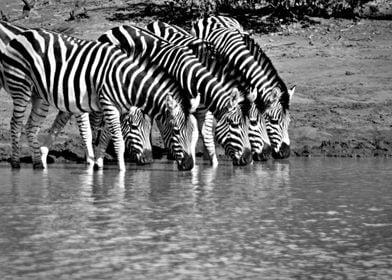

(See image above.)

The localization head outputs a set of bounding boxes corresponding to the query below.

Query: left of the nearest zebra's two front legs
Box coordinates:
[75,113,94,168]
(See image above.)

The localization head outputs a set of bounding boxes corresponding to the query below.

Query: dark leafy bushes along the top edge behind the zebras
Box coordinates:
[158,0,369,32]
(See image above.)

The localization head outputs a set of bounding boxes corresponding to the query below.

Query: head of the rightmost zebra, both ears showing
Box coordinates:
[265,87,295,159]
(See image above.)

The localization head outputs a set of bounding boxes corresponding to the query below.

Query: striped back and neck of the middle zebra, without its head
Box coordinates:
[98,26,247,122]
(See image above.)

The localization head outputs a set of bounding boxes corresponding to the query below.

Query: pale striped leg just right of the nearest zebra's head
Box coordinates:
[195,111,219,167]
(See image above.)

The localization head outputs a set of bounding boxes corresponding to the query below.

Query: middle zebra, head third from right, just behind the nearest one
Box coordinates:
[98,25,252,165]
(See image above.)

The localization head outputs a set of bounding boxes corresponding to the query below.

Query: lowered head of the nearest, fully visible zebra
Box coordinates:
[161,95,199,171]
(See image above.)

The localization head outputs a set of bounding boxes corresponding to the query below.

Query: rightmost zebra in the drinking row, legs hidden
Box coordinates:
[191,17,295,158]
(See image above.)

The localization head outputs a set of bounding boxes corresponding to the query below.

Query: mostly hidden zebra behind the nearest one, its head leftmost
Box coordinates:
[0,21,156,168]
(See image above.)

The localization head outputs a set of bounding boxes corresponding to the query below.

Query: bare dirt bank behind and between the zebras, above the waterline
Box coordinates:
[0,0,392,161]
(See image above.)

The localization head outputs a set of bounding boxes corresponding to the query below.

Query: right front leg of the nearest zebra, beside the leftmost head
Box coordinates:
[103,105,125,171]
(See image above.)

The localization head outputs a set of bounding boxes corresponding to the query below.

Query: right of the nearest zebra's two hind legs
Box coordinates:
[26,96,49,169]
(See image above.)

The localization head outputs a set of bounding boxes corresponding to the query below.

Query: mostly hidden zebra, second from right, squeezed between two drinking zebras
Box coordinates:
[146,21,270,164]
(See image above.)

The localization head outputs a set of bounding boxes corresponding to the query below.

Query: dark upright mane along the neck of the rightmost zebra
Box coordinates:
[237,30,290,109]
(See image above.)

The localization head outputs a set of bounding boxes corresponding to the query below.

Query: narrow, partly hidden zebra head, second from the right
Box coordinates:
[249,102,272,161]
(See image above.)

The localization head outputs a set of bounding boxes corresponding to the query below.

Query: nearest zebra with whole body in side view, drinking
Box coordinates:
[0,30,198,170]
